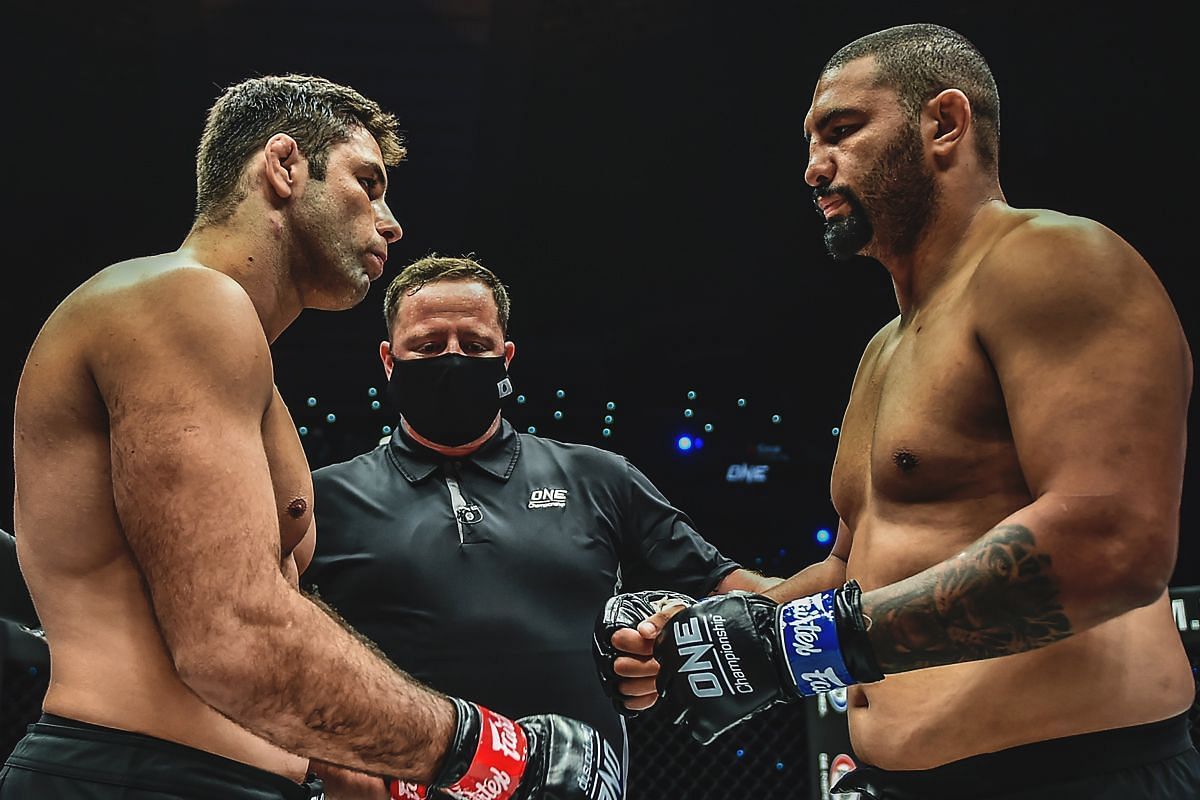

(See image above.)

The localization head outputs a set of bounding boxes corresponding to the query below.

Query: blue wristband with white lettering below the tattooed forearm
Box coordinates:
[775,589,856,697]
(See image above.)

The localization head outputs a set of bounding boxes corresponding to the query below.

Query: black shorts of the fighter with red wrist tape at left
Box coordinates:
[0,714,324,800]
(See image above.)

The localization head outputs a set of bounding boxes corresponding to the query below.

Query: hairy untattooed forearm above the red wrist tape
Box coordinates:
[181,589,455,783]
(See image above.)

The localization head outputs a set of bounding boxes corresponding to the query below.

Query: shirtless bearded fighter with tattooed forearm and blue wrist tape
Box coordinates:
[600,24,1200,800]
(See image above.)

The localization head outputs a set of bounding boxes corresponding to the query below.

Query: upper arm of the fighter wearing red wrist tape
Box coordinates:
[94,273,280,649]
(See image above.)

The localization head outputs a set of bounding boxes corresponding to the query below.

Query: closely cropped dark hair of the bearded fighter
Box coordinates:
[821,23,1000,169]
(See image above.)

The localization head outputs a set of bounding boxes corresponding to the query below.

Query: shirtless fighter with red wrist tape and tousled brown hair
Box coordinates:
[0,76,607,800]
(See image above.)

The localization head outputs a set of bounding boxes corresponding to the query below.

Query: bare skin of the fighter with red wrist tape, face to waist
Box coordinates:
[14,128,455,798]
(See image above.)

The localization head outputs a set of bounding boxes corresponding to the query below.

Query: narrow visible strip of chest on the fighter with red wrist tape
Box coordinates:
[263,391,313,557]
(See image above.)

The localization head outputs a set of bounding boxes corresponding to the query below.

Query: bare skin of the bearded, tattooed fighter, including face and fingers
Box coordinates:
[613,56,1195,770]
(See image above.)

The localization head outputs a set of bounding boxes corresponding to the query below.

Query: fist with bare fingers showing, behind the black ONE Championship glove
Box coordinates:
[592,590,696,717]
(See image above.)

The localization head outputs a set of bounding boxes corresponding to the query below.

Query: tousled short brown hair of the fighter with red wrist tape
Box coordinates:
[196,74,407,224]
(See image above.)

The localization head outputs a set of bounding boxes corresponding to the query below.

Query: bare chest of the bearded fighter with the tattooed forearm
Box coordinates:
[832,313,1012,528]
